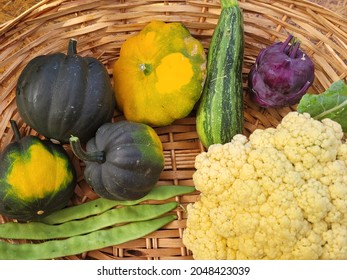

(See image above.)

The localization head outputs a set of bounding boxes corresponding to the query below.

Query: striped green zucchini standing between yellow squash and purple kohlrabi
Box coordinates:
[196,0,244,148]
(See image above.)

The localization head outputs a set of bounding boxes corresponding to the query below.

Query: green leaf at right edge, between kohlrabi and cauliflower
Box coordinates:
[297,80,347,132]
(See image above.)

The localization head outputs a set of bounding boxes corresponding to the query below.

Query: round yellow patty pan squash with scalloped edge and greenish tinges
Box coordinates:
[113,21,206,126]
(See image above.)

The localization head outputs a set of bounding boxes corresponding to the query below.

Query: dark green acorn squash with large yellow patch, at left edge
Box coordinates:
[0,121,76,221]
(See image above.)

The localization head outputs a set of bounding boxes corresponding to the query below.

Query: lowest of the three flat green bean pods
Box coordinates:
[0,215,177,260]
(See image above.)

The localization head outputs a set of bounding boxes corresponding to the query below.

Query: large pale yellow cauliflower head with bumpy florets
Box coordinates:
[183,112,347,259]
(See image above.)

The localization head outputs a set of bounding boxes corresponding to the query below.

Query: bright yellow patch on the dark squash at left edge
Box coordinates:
[7,143,73,200]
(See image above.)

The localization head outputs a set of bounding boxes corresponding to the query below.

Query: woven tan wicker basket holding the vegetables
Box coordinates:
[0,0,347,260]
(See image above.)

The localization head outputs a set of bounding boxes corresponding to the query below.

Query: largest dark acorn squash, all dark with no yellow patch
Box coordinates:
[16,39,115,143]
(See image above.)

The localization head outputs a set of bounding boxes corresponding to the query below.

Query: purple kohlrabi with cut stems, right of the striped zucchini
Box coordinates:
[248,35,314,107]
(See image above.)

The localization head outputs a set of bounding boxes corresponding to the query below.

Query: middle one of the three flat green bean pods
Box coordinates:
[0,202,178,240]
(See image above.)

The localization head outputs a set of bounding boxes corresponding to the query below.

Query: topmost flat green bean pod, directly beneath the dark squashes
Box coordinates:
[40,185,195,224]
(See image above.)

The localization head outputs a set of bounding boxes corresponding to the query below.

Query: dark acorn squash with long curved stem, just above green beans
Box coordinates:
[70,121,164,200]
